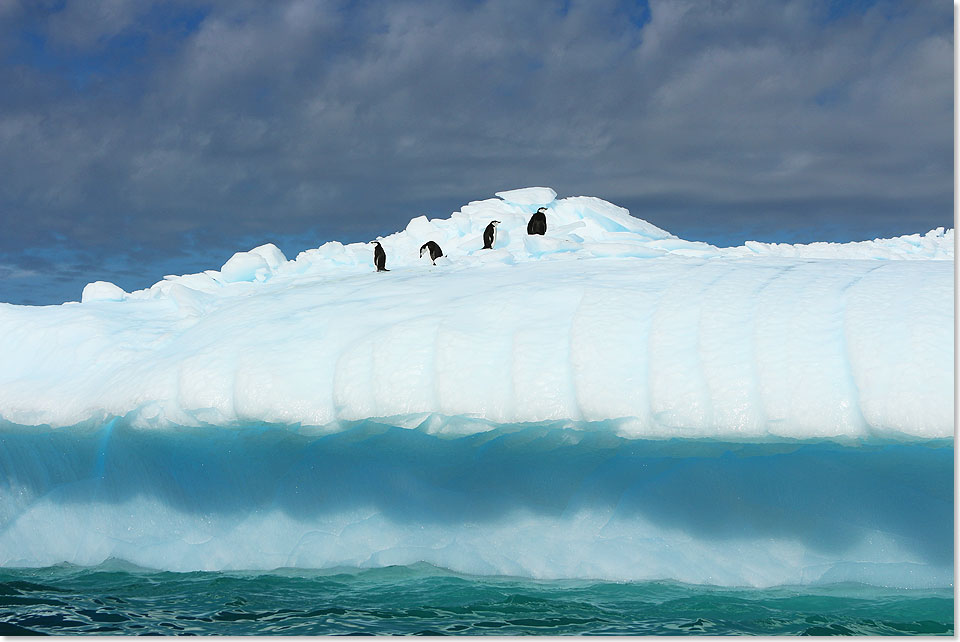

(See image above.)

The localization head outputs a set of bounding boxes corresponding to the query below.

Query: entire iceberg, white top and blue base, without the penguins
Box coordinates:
[0,188,954,586]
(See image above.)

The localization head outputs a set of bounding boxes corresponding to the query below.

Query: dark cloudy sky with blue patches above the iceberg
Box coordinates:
[0,0,954,305]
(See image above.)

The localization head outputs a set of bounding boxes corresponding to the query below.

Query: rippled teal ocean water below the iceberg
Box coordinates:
[0,560,954,635]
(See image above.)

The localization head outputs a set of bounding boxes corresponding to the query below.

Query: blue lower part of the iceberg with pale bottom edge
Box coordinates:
[0,425,953,586]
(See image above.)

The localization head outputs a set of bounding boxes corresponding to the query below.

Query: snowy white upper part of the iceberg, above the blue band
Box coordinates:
[0,188,953,441]
